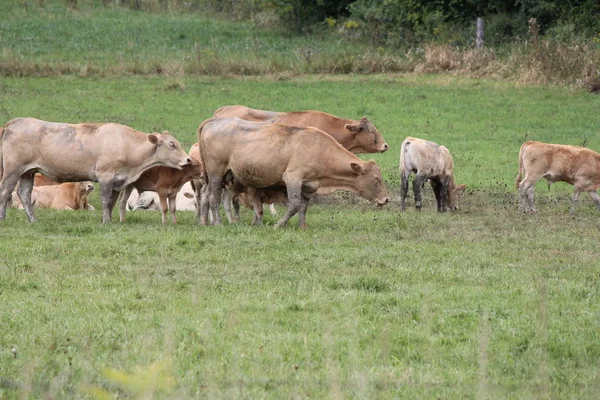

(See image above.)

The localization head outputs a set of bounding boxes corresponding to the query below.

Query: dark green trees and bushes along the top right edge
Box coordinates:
[268,0,600,45]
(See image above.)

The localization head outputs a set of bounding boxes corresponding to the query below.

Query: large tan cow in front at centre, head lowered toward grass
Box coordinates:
[198,117,389,229]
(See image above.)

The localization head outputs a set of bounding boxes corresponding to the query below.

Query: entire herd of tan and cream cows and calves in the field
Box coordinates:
[0,106,600,228]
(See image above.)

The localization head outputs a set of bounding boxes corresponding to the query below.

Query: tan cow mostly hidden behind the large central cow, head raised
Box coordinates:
[213,105,389,154]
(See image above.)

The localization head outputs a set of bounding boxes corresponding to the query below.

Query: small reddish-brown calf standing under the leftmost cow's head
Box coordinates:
[119,158,202,224]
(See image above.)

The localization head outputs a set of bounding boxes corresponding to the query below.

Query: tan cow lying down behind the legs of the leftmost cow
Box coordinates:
[12,181,94,211]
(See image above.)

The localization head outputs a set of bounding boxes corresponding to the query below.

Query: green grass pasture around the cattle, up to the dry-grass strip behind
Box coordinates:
[0,76,600,399]
